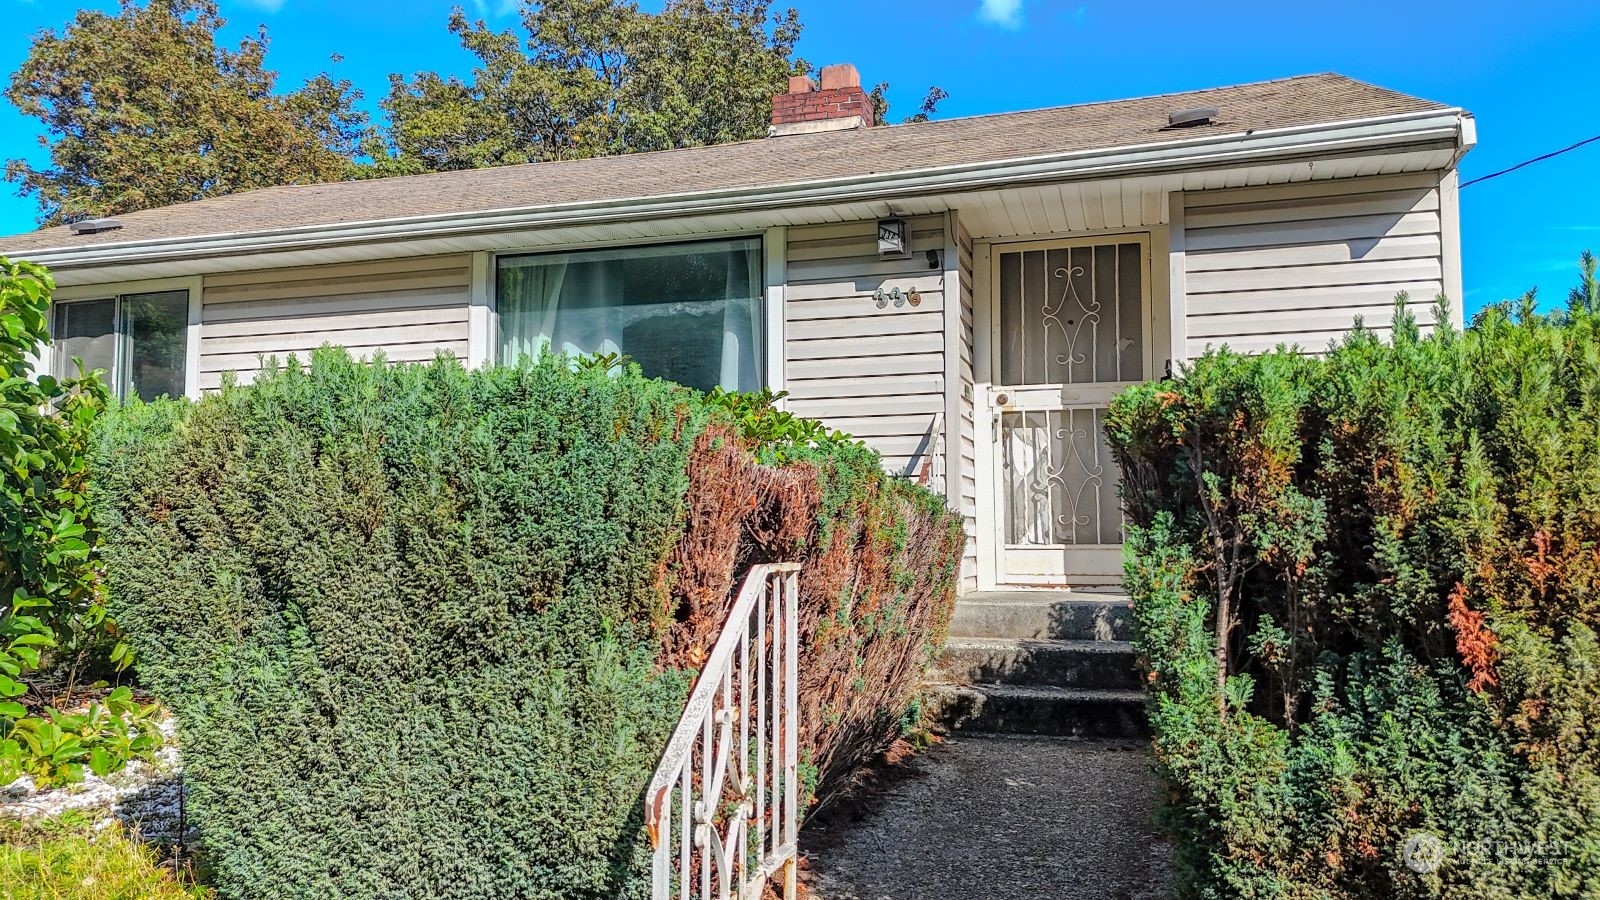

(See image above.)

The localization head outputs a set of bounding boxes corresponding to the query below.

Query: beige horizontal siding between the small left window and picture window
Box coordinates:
[200,253,472,391]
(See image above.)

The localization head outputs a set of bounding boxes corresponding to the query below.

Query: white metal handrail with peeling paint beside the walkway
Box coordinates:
[645,562,800,900]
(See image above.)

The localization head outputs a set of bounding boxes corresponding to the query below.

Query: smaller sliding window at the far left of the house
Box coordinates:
[53,290,189,400]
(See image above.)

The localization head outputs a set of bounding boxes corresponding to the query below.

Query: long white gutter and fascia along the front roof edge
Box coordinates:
[15,109,1469,269]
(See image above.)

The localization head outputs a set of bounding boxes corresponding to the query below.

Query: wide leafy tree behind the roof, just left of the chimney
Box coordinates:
[373,0,806,173]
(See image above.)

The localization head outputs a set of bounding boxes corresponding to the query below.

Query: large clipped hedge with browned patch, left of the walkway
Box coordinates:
[96,349,960,898]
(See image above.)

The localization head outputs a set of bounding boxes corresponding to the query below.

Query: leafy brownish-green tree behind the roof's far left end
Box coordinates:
[6,0,366,224]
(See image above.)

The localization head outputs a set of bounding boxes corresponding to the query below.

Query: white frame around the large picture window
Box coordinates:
[489,226,771,392]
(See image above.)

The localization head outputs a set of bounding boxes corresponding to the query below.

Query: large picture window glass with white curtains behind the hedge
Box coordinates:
[496,239,763,391]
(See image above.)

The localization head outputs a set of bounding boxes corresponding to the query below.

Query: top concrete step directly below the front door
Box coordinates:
[950,591,1133,641]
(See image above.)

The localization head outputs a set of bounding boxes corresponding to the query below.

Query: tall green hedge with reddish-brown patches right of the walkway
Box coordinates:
[1110,293,1600,900]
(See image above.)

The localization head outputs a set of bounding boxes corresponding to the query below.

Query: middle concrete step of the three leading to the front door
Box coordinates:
[931,637,1139,689]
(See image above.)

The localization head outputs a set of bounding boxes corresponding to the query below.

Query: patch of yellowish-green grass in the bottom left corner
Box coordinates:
[0,814,211,900]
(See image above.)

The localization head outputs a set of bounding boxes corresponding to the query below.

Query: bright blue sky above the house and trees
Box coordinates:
[0,0,1600,312]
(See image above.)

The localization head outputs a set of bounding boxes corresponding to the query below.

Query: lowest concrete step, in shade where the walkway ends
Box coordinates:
[928,684,1150,738]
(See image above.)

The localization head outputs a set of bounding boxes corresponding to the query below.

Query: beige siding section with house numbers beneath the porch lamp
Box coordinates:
[784,216,946,474]
